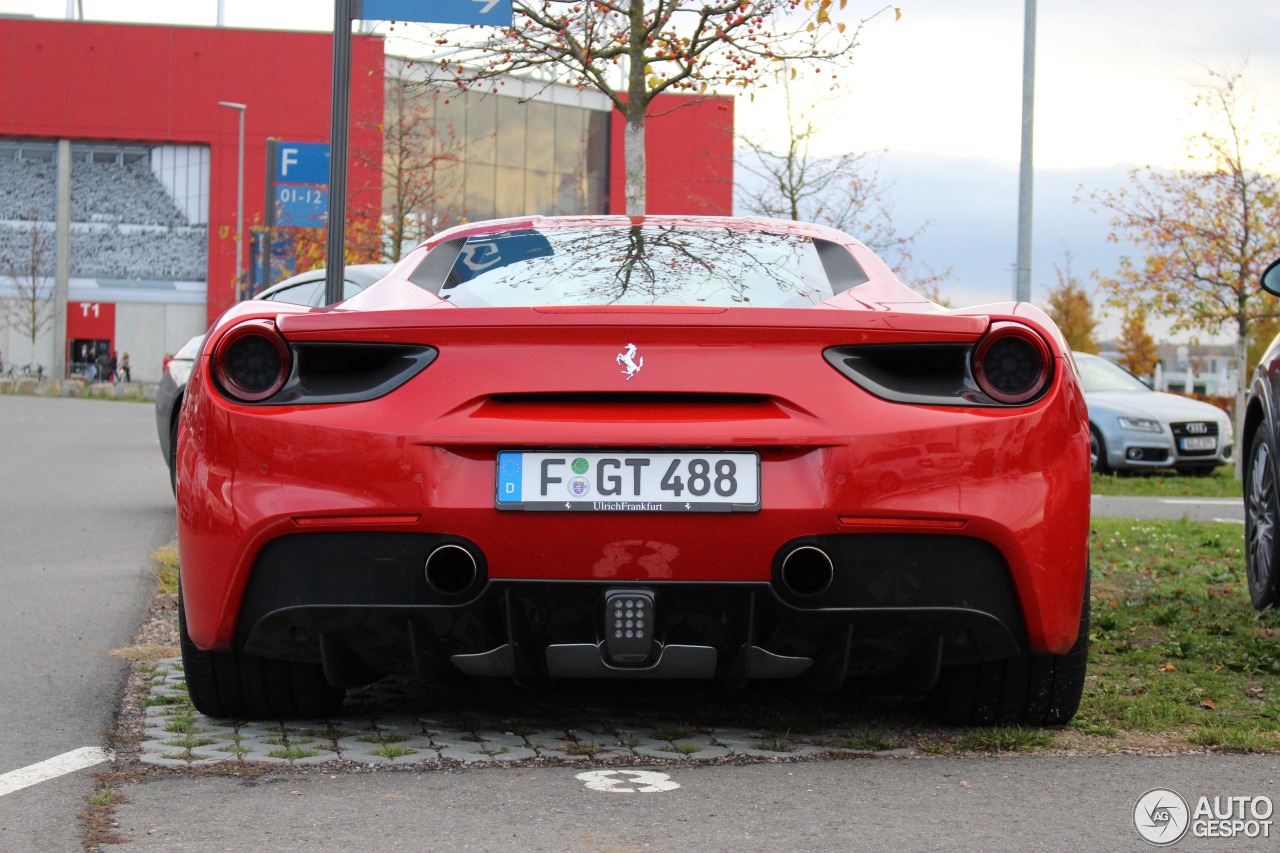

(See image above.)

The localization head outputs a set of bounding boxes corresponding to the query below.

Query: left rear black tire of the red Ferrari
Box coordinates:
[178,596,347,720]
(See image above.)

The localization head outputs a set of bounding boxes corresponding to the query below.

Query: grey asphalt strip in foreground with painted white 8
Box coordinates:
[120,756,1280,853]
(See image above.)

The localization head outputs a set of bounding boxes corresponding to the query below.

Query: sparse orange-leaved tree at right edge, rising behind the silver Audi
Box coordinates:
[1091,65,1280,435]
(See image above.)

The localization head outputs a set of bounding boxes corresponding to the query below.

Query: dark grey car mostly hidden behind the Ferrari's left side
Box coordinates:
[156,264,392,485]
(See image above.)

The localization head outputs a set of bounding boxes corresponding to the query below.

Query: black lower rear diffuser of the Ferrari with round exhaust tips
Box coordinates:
[237,533,1025,689]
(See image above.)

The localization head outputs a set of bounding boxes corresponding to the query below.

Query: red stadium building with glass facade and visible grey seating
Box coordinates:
[0,18,733,382]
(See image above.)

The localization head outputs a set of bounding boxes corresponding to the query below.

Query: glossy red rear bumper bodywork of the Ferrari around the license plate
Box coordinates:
[178,350,1089,655]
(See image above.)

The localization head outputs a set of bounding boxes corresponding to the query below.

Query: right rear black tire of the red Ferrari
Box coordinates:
[927,575,1089,726]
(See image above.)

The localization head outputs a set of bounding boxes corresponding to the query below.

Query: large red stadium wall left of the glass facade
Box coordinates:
[0,18,383,321]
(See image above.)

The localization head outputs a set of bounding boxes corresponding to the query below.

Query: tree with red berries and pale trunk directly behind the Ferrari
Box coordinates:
[414,0,900,215]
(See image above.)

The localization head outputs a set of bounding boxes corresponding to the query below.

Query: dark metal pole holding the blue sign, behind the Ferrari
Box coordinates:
[325,0,352,305]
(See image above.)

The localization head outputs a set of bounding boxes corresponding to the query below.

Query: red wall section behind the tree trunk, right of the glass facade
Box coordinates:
[609,95,733,216]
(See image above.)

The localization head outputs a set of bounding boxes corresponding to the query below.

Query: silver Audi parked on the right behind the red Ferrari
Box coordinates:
[1073,352,1235,475]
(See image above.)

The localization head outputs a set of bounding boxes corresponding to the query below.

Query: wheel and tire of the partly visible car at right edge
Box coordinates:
[1244,424,1280,610]
